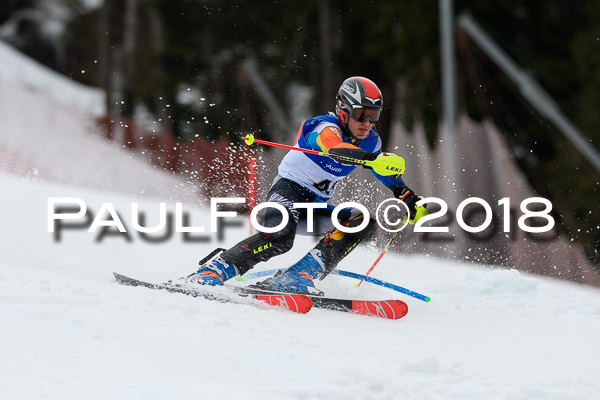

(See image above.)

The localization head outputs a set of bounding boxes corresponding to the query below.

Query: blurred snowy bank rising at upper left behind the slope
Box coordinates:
[0,41,201,203]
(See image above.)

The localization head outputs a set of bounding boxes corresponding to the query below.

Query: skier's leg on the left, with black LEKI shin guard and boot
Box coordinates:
[188,179,315,285]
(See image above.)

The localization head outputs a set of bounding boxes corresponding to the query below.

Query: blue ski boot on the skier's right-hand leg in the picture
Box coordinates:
[256,249,325,296]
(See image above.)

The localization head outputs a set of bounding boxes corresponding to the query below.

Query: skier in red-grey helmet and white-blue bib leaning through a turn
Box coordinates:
[187,76,427,293]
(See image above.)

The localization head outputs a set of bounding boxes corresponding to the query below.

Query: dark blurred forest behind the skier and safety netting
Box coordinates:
[0,0,600,266]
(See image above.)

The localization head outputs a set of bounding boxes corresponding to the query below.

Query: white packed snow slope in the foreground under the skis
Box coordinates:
[0,175,600,399]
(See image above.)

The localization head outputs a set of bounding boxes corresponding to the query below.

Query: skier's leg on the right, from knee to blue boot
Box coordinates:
[264,210,376,293]
